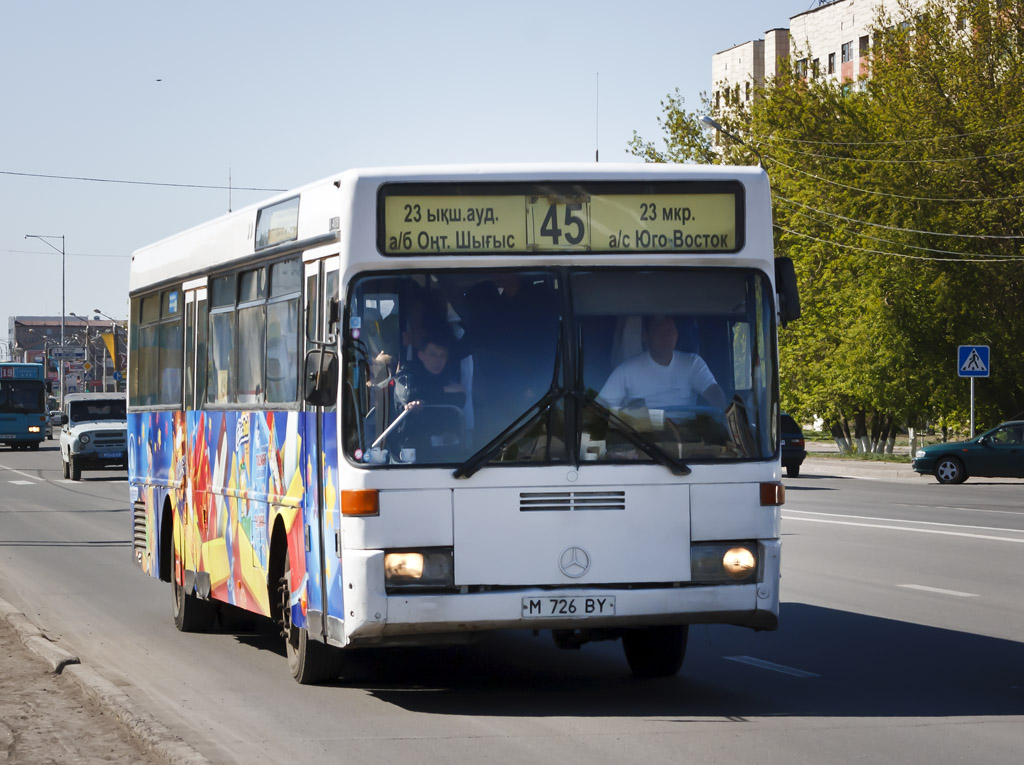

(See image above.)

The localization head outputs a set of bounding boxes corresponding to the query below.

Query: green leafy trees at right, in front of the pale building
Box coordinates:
[630,0,1024,425]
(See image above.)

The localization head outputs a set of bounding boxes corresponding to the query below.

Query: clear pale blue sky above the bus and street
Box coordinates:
[0,0,798,336]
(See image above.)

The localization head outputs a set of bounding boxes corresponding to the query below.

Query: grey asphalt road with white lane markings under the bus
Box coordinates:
[0,449,1024,765]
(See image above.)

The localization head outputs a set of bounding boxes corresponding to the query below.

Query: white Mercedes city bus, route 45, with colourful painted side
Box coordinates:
[129,164,799,683]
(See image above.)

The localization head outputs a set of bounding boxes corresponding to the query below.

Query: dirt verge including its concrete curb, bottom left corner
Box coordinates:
[0,598,208,765]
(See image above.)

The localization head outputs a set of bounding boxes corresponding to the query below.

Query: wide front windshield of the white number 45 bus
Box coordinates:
[344,267,778,469]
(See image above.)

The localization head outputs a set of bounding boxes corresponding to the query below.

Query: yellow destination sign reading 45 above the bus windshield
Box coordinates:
[378,182,742,255]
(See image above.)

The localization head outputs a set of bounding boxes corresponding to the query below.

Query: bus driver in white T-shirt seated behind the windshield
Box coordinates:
[597,315,726,409]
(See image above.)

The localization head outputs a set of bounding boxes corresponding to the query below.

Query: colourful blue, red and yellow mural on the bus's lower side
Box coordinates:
[128,411,344,627]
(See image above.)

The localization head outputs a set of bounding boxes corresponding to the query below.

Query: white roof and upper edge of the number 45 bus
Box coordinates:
[128,163,770,294]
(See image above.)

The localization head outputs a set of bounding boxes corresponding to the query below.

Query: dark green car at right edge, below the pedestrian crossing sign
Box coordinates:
[912,420,1024,483]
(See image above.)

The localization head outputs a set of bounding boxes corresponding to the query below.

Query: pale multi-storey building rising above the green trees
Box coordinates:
[711,0,925,112]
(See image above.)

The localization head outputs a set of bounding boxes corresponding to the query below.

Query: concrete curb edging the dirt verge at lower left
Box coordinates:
[0,598,210,765]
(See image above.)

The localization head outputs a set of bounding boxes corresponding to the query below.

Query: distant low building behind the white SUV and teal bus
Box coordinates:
[6,316,128,395]
